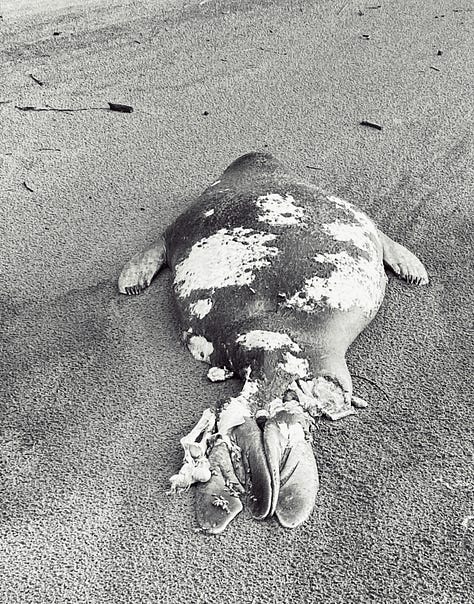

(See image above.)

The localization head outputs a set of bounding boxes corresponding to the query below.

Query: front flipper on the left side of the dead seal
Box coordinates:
[118,237,166,295]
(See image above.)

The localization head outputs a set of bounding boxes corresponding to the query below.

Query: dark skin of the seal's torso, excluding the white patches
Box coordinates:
[165,154,386,396]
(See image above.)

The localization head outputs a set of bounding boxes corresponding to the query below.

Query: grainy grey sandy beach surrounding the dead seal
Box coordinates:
[0,0,474,604]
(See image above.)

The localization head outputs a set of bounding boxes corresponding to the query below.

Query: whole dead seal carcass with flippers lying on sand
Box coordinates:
[119,153,428,533]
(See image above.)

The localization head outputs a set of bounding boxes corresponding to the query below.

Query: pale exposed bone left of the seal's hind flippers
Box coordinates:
[168,408,216,493]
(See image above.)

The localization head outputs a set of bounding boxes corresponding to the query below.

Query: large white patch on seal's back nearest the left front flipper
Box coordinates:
[174,227,279,298]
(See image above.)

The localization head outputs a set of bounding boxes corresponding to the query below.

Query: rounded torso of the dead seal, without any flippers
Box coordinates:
[165,154,386,396]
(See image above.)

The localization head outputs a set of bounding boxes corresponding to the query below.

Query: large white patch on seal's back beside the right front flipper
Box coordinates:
[284,251,386,316]
